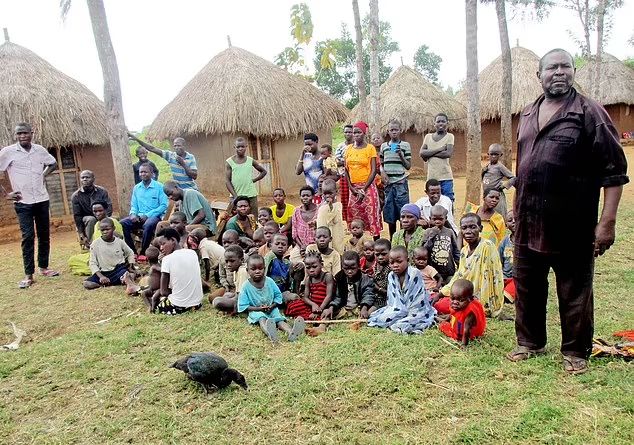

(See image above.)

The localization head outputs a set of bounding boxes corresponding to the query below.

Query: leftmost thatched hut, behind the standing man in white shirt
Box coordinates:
[0,41,117,229]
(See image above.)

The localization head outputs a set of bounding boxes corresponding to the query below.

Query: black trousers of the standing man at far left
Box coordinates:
[14,201,51,275]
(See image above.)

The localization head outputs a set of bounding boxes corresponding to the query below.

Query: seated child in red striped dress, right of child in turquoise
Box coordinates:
[284,250,335,320]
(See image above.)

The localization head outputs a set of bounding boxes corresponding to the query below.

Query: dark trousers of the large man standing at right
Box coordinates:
[513,244,594,358]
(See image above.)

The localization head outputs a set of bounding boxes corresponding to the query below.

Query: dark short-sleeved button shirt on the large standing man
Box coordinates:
[515,88,629,253]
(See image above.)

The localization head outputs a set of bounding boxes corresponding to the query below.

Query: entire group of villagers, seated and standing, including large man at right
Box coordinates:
[0,49,628,373]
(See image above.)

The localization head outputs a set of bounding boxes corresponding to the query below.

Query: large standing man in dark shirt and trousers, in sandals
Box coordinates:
[507,49,629,374]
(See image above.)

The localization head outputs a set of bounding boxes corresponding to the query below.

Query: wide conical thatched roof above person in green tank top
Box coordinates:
[148,47,348,139]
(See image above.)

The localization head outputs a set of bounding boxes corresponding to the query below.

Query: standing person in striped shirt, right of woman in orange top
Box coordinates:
[379,120,412,238]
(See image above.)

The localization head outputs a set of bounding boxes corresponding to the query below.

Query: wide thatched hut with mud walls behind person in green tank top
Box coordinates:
[148,47,348,196]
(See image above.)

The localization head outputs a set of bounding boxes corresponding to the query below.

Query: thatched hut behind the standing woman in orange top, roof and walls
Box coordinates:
[350,65,467,174]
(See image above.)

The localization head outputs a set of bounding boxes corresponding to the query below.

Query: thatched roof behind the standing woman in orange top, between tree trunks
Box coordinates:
[351,65,467,133]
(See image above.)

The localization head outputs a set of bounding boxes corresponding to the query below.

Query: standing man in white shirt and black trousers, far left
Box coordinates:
[0,122,59,289]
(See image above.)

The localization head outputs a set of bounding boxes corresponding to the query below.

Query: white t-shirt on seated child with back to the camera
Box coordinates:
[161,249,203,307]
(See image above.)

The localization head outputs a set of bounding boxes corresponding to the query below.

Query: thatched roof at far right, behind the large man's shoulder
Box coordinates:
[575,53,634,105]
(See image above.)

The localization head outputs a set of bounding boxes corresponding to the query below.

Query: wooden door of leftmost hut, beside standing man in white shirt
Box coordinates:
[46,147,79,216]
